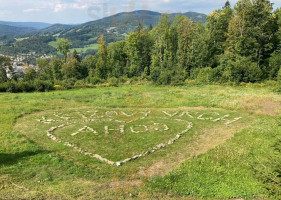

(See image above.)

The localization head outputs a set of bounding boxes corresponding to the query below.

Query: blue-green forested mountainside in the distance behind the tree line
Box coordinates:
[0,10,206,55]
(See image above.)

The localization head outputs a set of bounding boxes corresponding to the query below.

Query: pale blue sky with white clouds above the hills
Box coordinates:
[0,0,281,24]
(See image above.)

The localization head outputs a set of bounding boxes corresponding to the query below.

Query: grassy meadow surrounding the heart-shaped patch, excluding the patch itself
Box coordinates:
[0,86,281,199]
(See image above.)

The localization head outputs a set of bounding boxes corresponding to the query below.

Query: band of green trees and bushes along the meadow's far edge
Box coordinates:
[0,0,281,91]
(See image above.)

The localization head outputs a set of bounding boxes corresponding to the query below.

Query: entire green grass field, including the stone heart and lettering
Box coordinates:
[0,85,281,199]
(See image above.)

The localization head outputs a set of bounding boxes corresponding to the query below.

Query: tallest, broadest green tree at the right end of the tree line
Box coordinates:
[227,0,276,67]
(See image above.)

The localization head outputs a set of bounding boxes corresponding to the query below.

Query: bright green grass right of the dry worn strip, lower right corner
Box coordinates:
[149,117,281,199]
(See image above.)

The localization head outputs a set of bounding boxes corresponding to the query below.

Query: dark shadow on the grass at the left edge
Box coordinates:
[0,150,48,167]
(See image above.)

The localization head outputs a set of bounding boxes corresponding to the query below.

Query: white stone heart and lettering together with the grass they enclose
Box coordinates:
[30,108,242,166]
